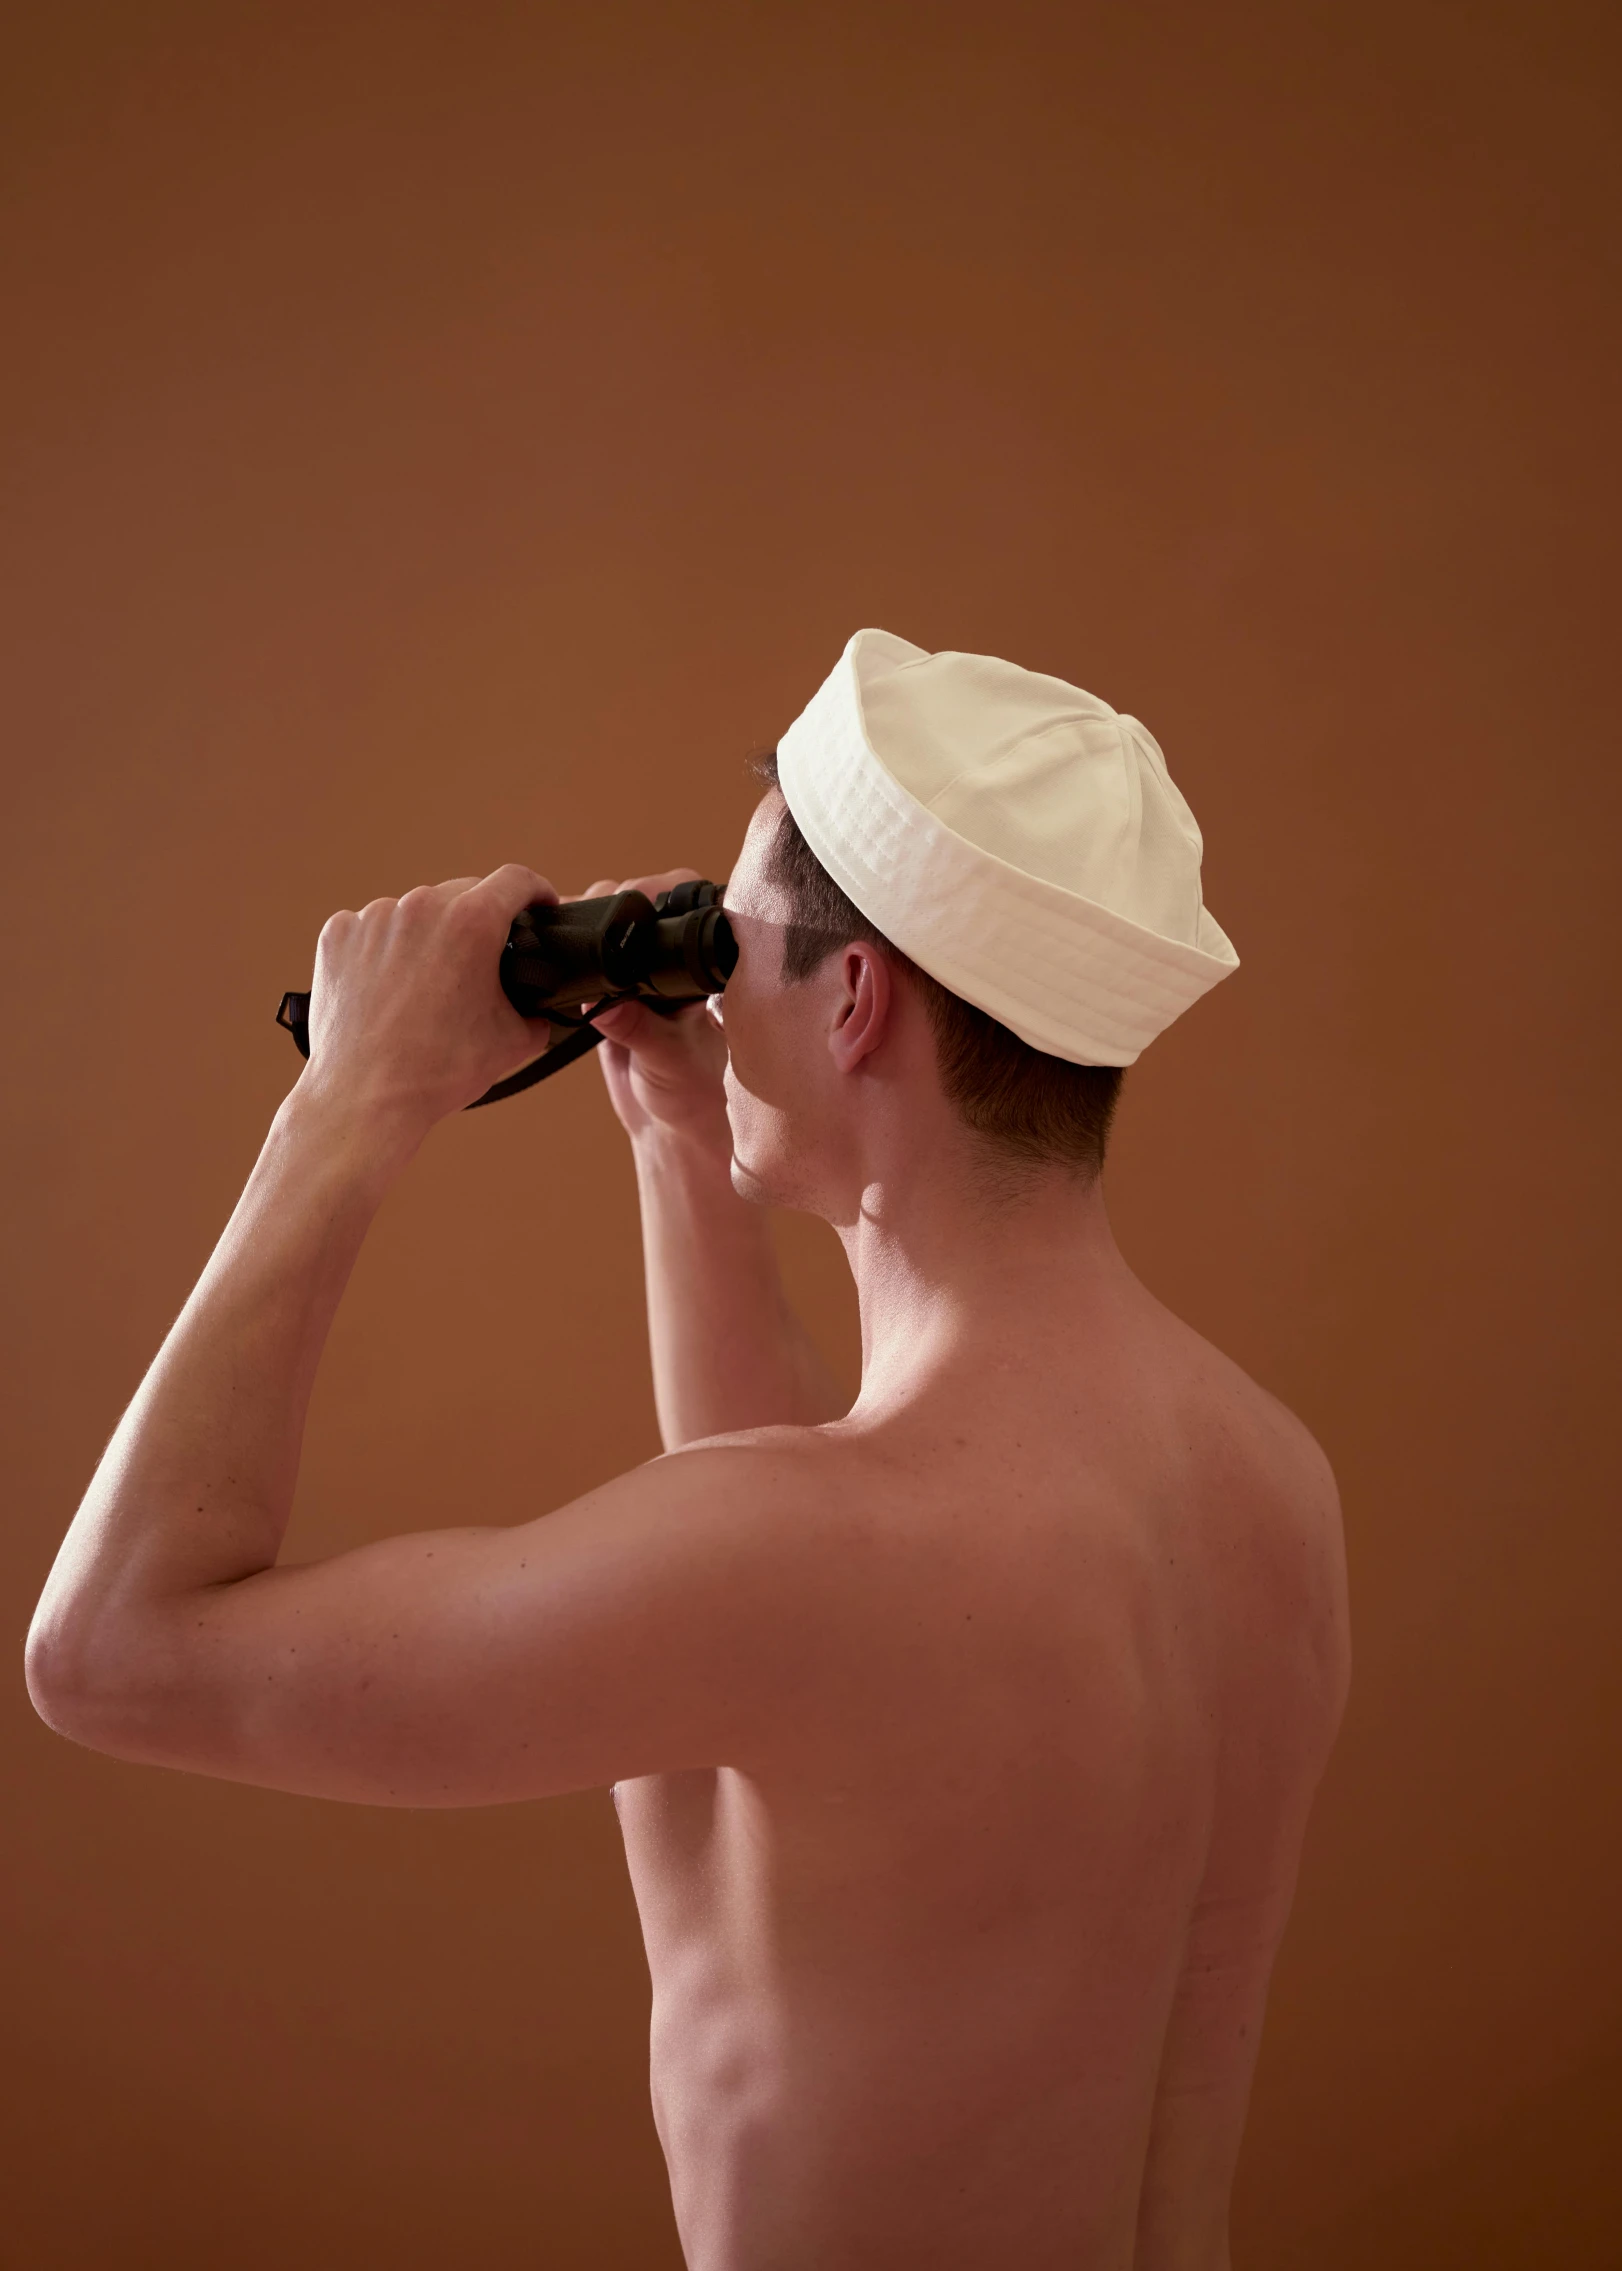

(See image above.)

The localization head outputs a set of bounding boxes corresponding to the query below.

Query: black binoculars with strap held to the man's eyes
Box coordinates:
[275,883,738,1111]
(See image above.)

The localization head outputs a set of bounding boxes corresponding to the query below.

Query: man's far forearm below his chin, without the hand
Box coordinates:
[636,1122,850,1451]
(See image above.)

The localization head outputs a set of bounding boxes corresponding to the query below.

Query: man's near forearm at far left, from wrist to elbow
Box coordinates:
[30,1081,418,1692]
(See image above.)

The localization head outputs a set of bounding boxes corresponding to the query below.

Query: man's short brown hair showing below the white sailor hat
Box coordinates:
[754,749,1122,1179]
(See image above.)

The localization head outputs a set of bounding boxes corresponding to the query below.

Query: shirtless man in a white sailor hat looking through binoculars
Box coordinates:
[27,634,1347,2271]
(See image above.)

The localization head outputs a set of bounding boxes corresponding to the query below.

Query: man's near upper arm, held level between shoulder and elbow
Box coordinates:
[118,1453,791,1805]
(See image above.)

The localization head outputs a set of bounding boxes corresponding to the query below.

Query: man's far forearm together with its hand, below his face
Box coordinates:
[591,870,850,1451]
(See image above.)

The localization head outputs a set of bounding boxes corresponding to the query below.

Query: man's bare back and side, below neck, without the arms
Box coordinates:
[616,1292,1347,2271]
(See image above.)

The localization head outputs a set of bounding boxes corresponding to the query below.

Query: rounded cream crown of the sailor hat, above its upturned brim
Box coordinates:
[852,631,1204,947]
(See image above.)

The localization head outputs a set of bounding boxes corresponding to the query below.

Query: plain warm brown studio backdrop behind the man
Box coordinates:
[0,0,1622,2271]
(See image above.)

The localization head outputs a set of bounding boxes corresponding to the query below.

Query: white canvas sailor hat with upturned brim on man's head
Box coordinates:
[777,631,1238,1065]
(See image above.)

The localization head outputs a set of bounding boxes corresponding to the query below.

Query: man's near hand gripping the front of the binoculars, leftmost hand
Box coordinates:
[300,865,557,1138]
